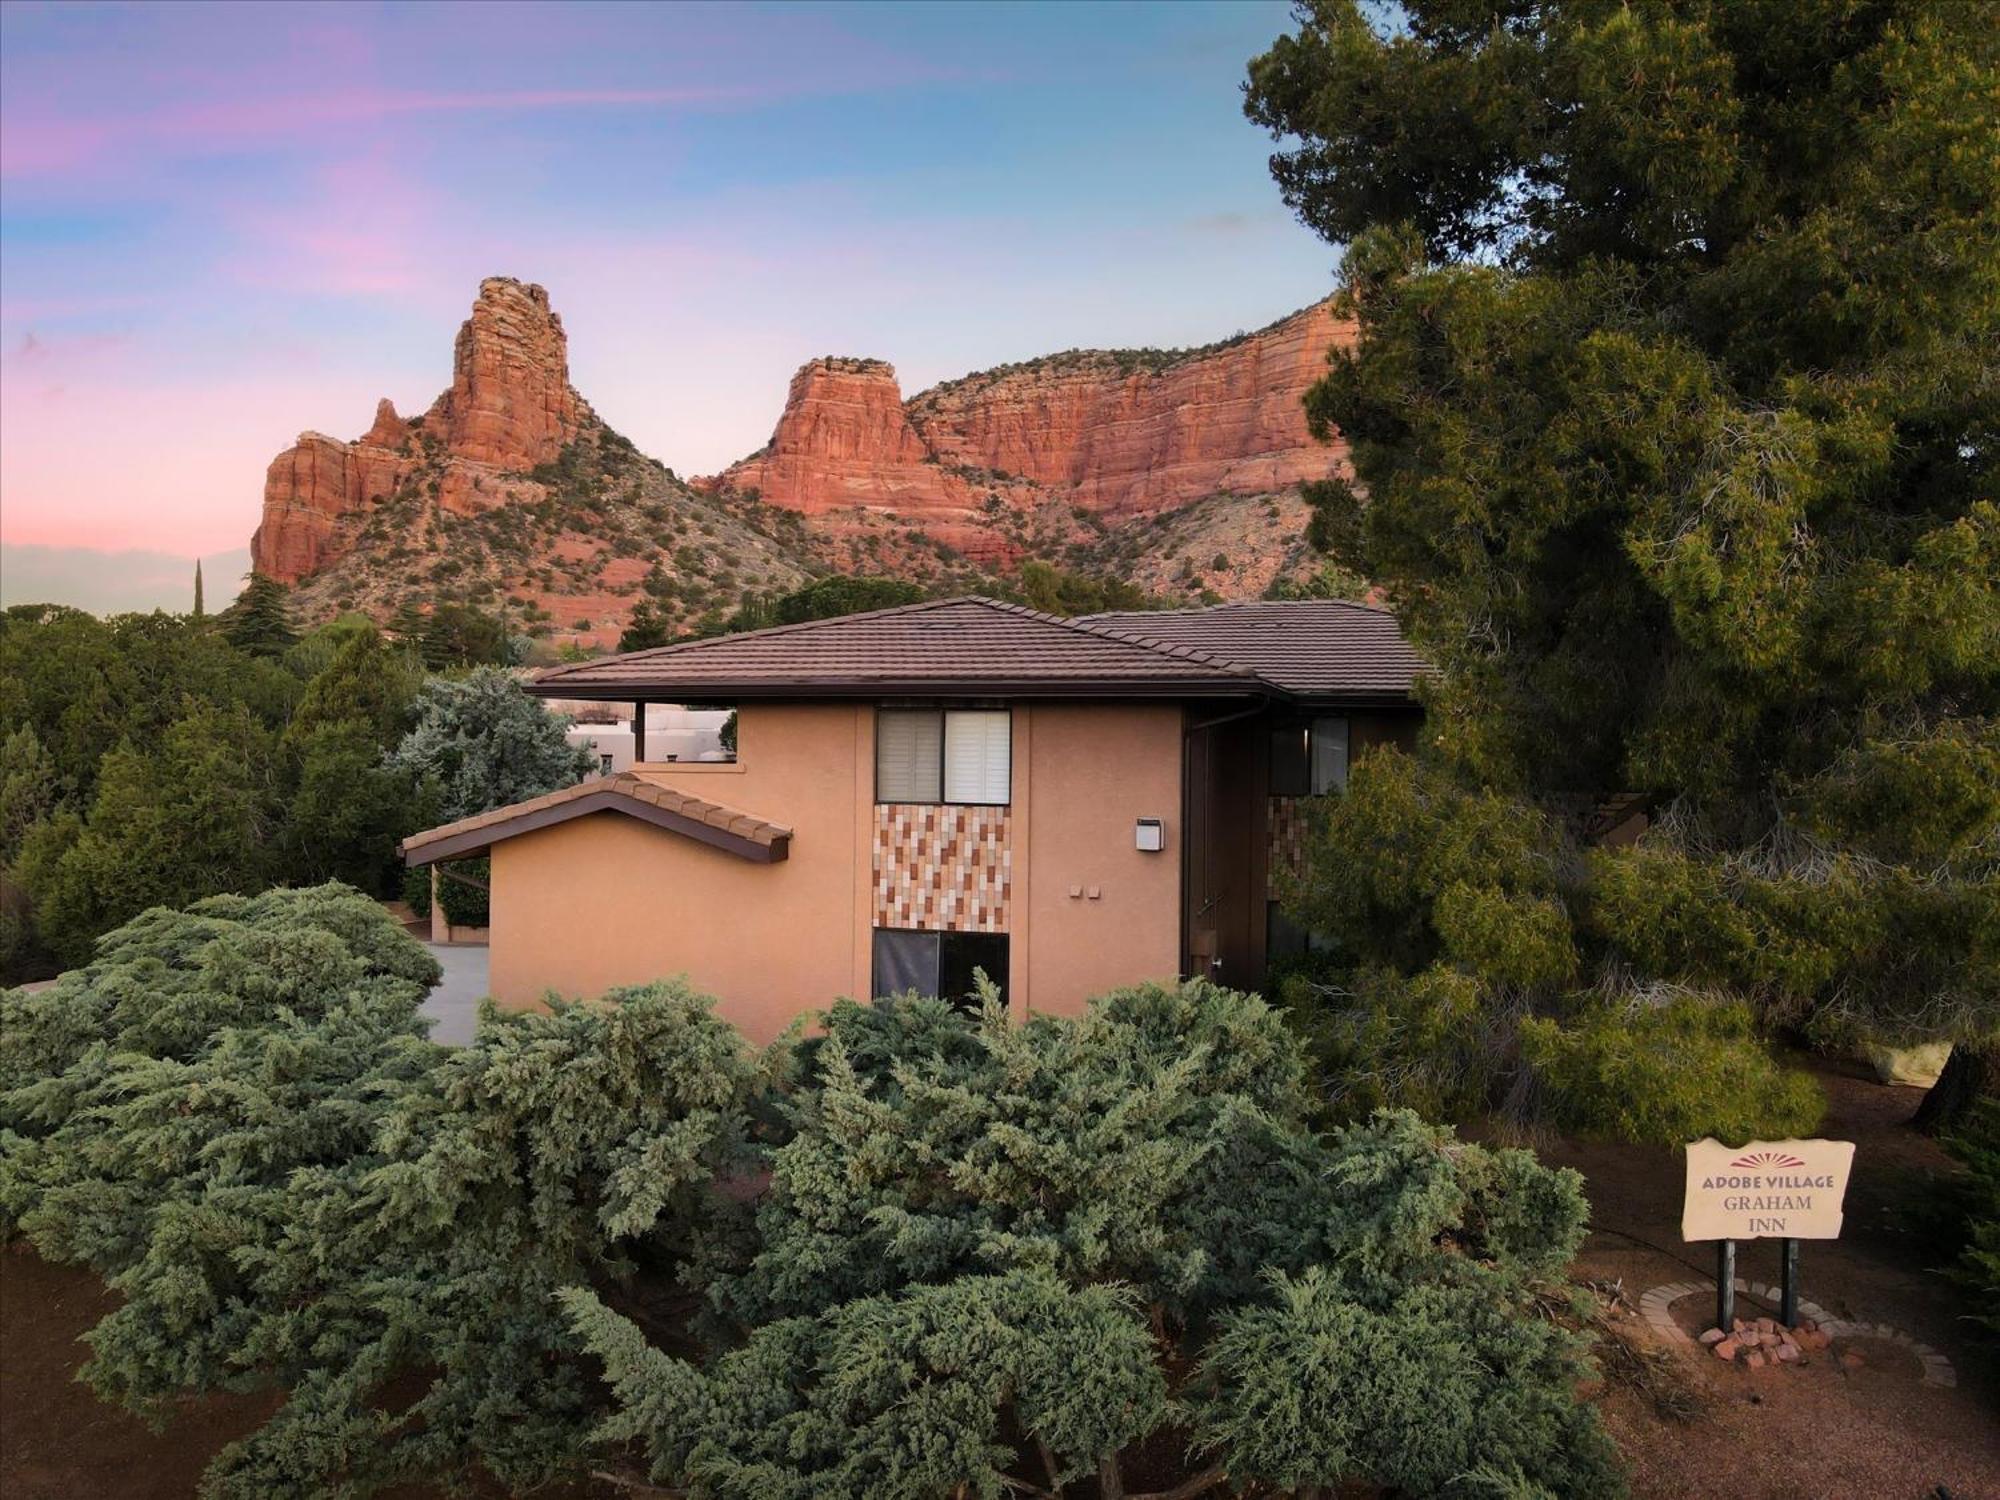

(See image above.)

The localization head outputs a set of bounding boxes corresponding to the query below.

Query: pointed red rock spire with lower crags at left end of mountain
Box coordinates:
[250,276,590,582]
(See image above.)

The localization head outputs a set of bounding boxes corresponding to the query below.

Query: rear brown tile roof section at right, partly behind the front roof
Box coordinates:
[1080,600,1430,698]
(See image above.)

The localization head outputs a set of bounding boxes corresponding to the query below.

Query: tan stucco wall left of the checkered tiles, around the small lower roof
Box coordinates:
[490,704,874,1042]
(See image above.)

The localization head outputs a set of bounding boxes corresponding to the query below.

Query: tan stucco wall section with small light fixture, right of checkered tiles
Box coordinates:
[1008,704,1180,1016]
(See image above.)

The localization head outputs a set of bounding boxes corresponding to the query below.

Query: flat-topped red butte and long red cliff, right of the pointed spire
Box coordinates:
[716,304,1354,518]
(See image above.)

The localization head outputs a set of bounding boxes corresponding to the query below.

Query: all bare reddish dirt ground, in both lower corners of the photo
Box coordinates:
[0,1068,2000,1500]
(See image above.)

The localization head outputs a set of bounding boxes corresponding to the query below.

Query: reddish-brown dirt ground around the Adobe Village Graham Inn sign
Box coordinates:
[1540,1064,2000,1500]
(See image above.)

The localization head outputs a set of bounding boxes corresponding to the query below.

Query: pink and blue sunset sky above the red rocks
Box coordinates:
[0,0,1336,602]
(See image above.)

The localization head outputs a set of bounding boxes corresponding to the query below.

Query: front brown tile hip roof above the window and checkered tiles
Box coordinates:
[530,598,1264,702]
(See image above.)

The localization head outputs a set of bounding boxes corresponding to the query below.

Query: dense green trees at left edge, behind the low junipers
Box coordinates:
[0,606,578,978]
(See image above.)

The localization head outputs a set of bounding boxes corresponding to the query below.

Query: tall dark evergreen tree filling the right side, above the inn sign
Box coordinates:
[1246,0,2000,1130]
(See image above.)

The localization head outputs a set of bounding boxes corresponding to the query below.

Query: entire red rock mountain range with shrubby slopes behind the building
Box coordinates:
[250,276,1352,646]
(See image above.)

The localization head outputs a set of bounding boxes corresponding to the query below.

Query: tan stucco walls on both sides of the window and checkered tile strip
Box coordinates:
[490,704,1180,1042]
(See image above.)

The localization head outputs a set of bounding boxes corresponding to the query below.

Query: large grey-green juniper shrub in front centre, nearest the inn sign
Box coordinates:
[566,982,1620,1500]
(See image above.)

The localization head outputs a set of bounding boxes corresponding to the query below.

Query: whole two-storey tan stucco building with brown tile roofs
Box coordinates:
[404,598,1424,1038]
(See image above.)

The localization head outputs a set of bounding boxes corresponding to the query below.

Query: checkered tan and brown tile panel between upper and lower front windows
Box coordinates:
[874,802,1014,932]
